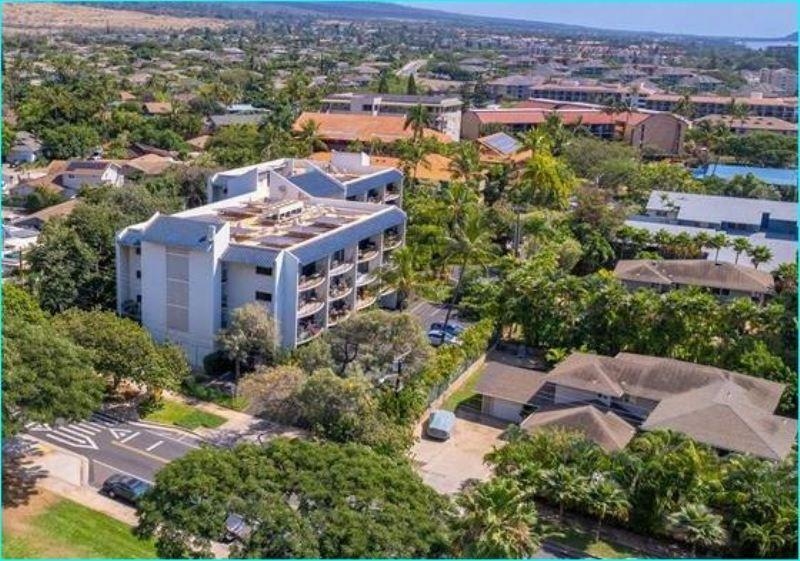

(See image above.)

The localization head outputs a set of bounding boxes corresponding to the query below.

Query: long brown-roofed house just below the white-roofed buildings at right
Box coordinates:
[614,259,775,303]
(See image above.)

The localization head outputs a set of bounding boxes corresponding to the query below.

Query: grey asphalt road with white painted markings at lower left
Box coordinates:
[26,413,202,487]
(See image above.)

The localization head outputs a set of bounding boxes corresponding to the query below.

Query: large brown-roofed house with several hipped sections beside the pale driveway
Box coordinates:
[475,353,797,461]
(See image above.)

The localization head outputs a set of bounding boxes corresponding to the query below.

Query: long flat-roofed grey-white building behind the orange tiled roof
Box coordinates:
[322,93,463,141]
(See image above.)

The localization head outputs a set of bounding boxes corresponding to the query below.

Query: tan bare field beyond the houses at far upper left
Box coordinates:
[3,3,245,35]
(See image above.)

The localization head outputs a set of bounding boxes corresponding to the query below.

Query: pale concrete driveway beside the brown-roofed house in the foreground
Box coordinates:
[411,416,505,494]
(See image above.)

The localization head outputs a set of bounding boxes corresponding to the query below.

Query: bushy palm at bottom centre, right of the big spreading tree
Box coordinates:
[455,478,557,559]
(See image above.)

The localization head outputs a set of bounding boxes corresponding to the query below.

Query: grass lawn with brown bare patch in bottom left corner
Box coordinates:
[3,494,157,559]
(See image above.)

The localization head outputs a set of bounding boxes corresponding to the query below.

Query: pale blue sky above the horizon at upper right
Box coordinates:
[406,0,798,37]
